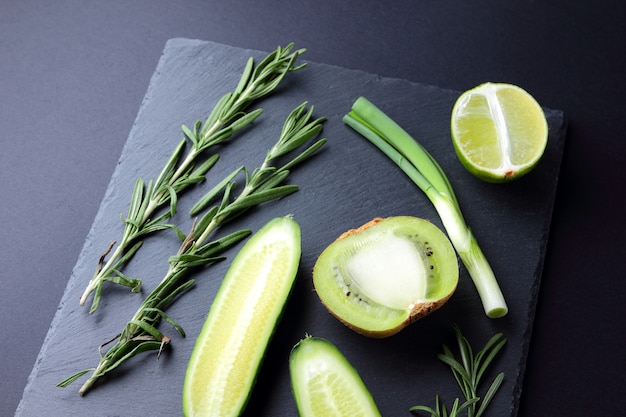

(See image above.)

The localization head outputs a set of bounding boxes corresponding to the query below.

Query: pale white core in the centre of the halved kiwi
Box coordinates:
[346,233,427,309]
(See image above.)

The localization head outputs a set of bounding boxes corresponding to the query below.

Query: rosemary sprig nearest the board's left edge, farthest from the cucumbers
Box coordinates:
[80,43,306,313]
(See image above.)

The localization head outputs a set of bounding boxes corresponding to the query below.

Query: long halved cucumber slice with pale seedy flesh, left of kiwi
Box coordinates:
[183,217,301,417]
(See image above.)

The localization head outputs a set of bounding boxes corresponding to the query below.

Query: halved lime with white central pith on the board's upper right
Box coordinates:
[451,83,548,182]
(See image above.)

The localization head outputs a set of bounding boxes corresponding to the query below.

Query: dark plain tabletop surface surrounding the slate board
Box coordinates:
[0,0,626,416]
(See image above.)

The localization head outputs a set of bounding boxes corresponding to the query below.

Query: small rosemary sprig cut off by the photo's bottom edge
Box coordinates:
[410,325,506,417]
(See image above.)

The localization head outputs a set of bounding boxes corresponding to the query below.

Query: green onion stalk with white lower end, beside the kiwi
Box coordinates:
[343,97,508,318]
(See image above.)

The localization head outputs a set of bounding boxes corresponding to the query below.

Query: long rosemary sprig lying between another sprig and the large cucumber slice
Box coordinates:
[57,103,326,395]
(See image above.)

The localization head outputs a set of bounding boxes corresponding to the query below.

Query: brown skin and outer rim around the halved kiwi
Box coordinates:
[313,216,458,338]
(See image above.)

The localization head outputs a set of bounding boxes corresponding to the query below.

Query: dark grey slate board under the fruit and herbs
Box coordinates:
[16,39,566,417]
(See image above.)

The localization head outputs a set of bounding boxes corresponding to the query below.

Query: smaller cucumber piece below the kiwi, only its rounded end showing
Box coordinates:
[289,336,381,417]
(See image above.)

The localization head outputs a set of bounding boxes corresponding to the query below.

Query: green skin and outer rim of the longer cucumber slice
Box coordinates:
[182,216,301,417]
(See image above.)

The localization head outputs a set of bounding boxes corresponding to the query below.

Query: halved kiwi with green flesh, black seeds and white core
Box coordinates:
[313,216,459,337]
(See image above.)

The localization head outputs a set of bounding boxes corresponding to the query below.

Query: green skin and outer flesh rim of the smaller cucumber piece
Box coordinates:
[289,336,381,417]
